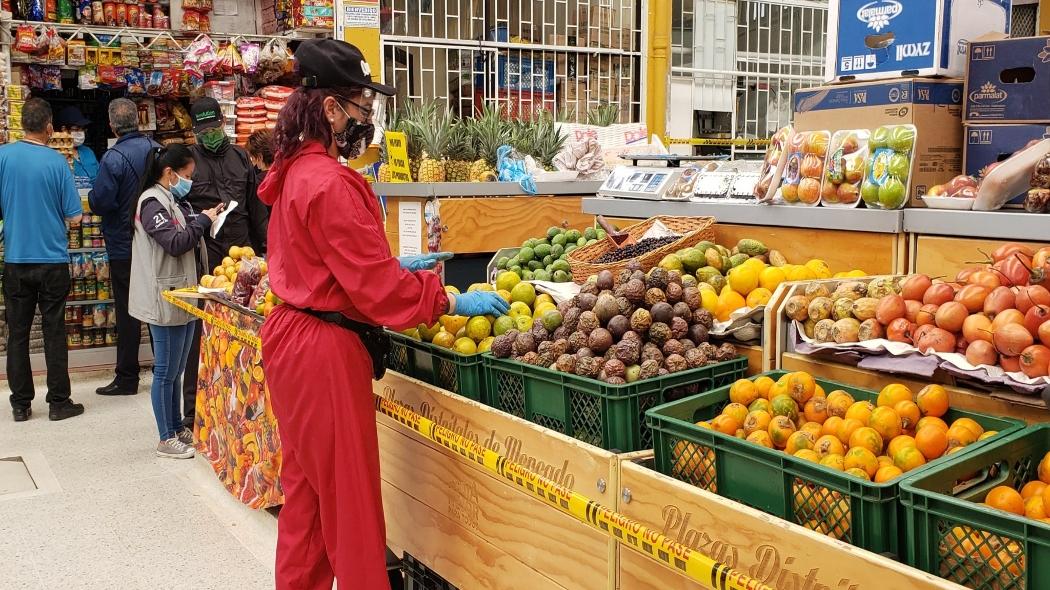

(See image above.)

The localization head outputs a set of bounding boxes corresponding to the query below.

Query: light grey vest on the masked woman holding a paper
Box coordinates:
[128,185,204,325]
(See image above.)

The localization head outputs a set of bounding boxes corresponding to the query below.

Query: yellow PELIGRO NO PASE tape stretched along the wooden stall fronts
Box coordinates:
[376,396,773,590]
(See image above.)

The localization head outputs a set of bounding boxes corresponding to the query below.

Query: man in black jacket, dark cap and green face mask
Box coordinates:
[183,98,270,428]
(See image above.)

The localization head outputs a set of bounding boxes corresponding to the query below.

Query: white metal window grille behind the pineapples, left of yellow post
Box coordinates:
[380,0,647,122]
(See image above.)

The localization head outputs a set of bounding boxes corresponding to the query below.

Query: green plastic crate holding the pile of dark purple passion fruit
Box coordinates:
[485,355,748,452]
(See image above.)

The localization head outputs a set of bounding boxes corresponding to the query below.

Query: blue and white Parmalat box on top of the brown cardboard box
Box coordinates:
[824,0,1010,82]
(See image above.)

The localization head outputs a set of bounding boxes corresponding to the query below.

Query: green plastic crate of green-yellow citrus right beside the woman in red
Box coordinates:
[386,332,488,403]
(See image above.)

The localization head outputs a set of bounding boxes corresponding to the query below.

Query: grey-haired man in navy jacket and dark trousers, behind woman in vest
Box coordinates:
[87,99,160,396]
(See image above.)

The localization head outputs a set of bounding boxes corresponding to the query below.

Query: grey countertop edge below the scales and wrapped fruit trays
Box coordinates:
[583,196,902,233]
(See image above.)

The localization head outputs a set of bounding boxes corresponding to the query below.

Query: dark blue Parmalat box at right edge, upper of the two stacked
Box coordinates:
[964,37,1050,123]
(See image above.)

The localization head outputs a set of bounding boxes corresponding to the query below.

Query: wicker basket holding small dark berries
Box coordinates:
[568,215,715,282]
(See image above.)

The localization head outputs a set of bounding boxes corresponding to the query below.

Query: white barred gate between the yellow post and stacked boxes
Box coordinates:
[668,0,827,154]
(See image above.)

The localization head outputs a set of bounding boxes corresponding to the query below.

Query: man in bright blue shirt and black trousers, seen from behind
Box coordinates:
[0,99,84,422]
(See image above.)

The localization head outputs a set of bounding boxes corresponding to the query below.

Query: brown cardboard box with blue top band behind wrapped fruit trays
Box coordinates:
[794,79,963,207]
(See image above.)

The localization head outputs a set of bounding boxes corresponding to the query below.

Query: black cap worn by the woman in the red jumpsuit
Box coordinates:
[295,39,395,97]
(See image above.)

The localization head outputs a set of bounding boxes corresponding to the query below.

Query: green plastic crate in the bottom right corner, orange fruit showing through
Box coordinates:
[901,424,1050,590]
